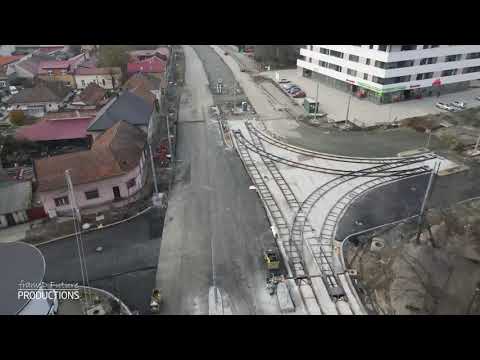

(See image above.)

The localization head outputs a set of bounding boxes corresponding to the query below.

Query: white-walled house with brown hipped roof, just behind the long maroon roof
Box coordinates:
[7,82,71,117]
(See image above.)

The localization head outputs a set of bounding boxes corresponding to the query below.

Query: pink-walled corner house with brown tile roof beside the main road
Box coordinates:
[34,121,147,217]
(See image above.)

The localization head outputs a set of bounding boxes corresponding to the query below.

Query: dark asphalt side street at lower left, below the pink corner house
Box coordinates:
[38,212,161,314]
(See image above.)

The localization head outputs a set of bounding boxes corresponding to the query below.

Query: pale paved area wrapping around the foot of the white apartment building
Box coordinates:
[260,69,480,127]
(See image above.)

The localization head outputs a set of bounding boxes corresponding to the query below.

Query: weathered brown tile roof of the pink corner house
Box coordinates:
[34,121,147,191]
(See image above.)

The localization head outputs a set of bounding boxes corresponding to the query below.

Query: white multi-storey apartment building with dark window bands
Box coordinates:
[297,45,480,103]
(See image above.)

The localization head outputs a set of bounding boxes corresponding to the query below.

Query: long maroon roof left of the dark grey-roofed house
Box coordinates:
[16,117,94,141]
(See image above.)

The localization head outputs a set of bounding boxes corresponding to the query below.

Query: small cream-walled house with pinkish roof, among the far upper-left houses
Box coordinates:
[75,66,122,89]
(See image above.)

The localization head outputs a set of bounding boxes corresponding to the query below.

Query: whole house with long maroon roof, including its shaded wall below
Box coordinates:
[15,111,95,150]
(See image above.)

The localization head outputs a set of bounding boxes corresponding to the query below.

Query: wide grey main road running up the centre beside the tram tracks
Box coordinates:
[157,46,277,314]
